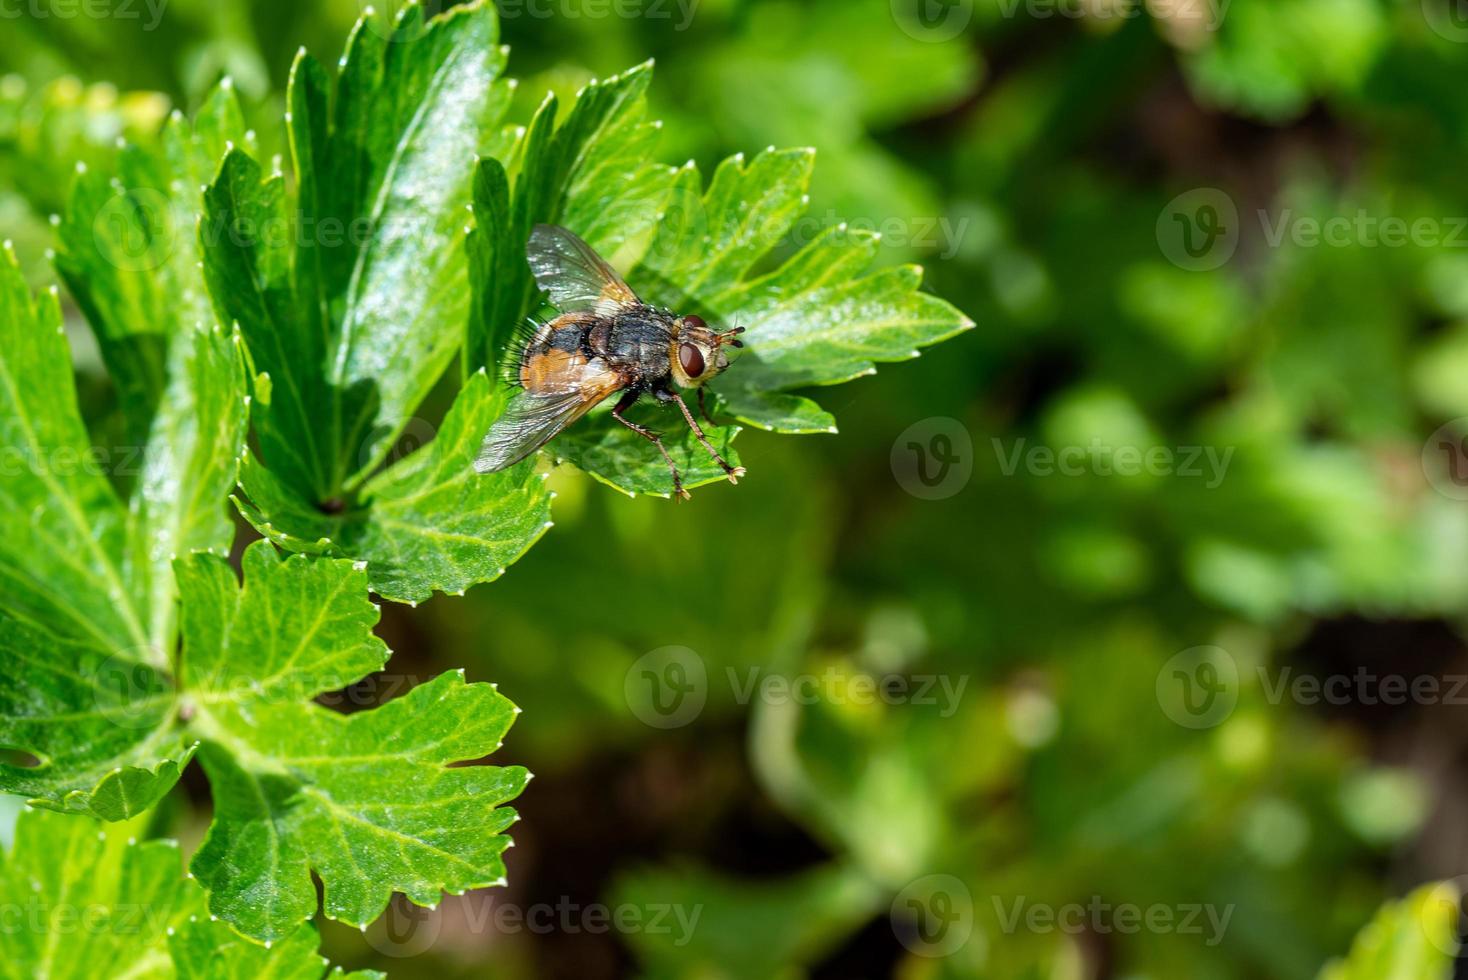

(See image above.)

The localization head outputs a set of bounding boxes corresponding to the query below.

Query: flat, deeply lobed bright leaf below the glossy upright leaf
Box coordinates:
[179,541,528,939]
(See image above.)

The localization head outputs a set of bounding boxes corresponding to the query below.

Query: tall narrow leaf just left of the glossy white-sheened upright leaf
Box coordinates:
[44,84,247,663]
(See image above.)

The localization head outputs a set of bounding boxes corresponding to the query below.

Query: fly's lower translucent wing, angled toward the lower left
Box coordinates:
[474,351,622,472]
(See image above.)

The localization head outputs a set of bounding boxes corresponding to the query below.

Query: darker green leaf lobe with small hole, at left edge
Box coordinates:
[0,615,194,820]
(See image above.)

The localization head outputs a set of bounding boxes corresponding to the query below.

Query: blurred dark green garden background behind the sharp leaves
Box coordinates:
[0,0,1468,980]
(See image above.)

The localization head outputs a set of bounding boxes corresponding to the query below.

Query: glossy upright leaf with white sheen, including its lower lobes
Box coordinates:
[215,4,549,601]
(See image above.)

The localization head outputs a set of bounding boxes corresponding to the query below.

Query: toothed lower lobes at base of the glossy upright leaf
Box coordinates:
[236,373,551,603]
